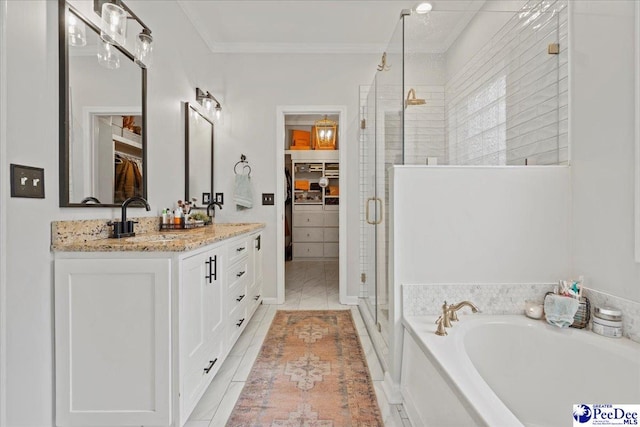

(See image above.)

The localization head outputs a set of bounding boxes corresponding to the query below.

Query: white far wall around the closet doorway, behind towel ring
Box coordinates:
[214,54,380,298]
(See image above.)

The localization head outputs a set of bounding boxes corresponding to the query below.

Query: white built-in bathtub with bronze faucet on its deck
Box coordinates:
[401,314,640,427]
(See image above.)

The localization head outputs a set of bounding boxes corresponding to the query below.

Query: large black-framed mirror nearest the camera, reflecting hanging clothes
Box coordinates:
[58,0,147,207]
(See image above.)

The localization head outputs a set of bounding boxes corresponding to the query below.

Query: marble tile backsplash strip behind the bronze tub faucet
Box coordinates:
[402,283,556,316]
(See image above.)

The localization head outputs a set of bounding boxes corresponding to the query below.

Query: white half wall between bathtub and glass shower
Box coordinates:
[390,166,571,392]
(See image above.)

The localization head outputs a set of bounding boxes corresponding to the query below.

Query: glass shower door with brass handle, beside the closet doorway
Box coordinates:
[360,20,404,355]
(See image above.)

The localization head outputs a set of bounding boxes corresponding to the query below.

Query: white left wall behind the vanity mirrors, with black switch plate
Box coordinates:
[2,0,224,427]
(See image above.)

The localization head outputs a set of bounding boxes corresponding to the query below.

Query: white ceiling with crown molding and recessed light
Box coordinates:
[178,0,484,53]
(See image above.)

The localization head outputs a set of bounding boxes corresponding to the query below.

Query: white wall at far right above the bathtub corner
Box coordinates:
[569,0,640,302]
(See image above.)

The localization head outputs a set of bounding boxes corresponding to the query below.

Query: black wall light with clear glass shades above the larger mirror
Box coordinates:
[93,0,153,68]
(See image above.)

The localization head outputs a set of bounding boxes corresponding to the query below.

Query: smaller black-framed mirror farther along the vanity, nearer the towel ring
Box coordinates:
[184,102,214,211]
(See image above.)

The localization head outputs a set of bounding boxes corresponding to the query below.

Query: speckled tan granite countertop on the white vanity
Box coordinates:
[51,217,265,252]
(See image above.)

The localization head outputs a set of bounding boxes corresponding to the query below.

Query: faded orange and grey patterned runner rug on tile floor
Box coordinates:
[227,310,383,427]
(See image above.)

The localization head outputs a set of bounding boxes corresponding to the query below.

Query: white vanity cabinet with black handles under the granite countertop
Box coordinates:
[54,231,262,427]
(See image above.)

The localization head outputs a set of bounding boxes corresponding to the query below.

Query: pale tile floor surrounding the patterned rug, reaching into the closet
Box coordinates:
[186,261,411,427]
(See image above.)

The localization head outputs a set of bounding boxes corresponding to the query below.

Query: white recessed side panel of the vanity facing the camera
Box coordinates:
[54,259,171,427]
